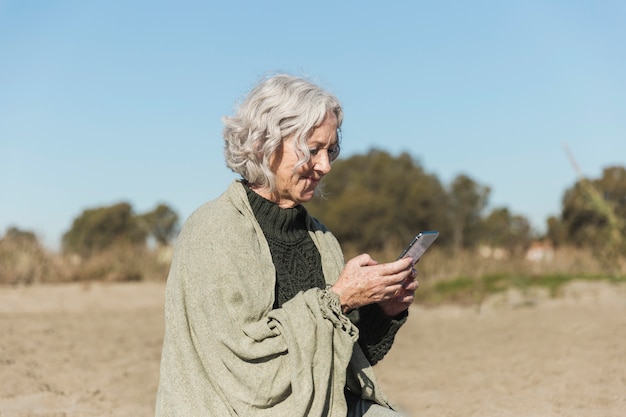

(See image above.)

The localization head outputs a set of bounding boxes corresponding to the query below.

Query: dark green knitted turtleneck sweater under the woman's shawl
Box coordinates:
[246,187,407,365]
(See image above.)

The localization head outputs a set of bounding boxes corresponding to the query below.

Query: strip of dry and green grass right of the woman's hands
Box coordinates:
[356,242,626,307]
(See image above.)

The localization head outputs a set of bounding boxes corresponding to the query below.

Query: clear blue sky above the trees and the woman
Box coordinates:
[0,0,626,248]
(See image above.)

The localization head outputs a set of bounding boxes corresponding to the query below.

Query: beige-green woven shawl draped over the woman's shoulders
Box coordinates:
[156,182,388,417]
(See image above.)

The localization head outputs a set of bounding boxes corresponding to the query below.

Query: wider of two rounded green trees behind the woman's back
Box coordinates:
[63,202,146,257]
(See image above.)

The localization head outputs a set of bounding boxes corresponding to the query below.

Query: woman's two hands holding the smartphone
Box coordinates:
[331,254,413,313]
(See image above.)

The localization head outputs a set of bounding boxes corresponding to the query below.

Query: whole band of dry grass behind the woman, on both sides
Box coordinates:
[0,239,626,305]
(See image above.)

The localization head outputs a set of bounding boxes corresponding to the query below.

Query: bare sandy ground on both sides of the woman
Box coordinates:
[0,283,626,417]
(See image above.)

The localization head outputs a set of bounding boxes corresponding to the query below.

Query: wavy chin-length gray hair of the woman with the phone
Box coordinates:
[222,74,343,191]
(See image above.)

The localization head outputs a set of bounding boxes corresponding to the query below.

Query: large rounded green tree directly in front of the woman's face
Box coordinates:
[307,149,447,251]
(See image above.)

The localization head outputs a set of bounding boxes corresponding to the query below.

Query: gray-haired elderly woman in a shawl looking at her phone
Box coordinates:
[156,75,417,417]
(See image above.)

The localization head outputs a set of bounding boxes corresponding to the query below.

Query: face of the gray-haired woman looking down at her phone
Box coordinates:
[257,113,339,208]
